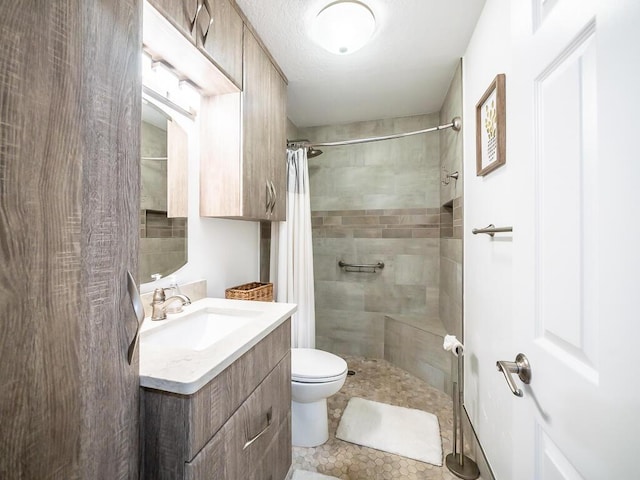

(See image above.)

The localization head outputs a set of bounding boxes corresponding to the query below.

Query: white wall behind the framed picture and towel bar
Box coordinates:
[463,0,517,479]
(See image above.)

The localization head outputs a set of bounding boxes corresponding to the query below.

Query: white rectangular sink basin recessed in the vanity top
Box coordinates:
[140,307,262,351]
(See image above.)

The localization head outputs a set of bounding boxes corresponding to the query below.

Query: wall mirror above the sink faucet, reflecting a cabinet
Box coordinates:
[138,97,188,283]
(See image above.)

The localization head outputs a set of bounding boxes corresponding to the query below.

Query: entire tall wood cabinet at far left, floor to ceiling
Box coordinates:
[0,0,140,479]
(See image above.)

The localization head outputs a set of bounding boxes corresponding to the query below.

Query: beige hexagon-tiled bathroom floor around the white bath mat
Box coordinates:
[293,355,480,480]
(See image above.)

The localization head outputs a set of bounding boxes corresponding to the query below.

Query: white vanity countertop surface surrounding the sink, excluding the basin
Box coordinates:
[140,298,298,395]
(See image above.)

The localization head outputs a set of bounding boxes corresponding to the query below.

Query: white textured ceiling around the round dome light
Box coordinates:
[236,0,485,127]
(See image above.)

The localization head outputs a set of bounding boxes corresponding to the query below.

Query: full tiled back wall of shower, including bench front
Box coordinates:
[299,113,450,391]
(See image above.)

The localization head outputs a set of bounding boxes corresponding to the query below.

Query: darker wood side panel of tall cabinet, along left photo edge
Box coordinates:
[0,1,82,478]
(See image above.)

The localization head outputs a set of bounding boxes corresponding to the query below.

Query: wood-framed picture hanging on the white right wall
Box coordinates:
[476,73,507,177]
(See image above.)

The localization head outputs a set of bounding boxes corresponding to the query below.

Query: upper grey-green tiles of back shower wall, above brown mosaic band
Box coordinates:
[298,113,440,210]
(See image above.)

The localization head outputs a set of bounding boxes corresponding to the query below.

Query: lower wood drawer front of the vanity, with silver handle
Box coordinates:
[184,353,291,480]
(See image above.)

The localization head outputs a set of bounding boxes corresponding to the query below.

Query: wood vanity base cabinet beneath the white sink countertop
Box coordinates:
[140,320,291,480]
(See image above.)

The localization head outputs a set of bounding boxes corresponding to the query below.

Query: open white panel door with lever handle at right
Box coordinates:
[508,0,640,480]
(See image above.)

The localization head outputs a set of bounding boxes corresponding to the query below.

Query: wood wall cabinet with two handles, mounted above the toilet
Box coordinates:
[200,26,287,221]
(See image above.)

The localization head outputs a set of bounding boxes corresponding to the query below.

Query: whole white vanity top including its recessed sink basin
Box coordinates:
[140,298,296,395]
